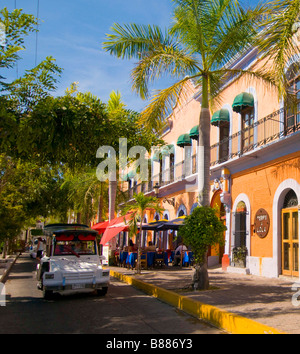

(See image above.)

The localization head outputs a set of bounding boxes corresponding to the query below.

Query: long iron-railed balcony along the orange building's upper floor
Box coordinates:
[122,109,300,200]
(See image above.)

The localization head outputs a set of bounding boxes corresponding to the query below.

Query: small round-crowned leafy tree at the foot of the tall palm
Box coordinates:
[179,207,226,289]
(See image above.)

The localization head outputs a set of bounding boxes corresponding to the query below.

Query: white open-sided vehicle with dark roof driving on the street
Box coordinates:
[37,224,110,299]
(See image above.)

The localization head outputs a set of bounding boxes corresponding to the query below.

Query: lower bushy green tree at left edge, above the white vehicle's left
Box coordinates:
[0,154,68,256]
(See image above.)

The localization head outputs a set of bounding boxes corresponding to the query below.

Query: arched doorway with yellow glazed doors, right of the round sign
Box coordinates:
[281,189,299,277]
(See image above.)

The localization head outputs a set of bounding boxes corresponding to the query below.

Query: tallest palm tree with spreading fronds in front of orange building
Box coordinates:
[103,0,274,206]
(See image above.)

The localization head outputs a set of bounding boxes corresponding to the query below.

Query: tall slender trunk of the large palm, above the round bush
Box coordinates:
[198,76,210,206]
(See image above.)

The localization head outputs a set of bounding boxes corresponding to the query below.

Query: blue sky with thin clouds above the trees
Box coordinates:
[1,0,257,111]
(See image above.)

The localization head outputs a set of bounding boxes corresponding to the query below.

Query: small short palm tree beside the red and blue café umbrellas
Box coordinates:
[122,193,163,274]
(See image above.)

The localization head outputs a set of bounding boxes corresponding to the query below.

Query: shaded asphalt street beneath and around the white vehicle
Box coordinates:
[0,255,223,338]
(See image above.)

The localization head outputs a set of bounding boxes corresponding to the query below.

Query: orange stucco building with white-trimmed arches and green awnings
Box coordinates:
[118,39,300,277]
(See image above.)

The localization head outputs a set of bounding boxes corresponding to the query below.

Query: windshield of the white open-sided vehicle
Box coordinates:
[54,241,96,256]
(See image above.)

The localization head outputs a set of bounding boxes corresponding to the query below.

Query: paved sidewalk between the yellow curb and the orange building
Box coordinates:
[109,267,300,334]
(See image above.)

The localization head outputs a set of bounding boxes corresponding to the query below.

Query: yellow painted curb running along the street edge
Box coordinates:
[110,270,284,334]
